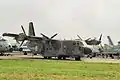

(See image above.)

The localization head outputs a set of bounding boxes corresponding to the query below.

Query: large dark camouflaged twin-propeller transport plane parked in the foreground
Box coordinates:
[3,22,91,60]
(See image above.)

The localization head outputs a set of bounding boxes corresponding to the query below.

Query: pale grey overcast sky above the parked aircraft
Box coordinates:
[0,0,120,43]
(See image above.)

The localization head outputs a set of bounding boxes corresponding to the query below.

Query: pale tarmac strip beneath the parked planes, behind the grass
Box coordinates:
[0,52,120,63]
